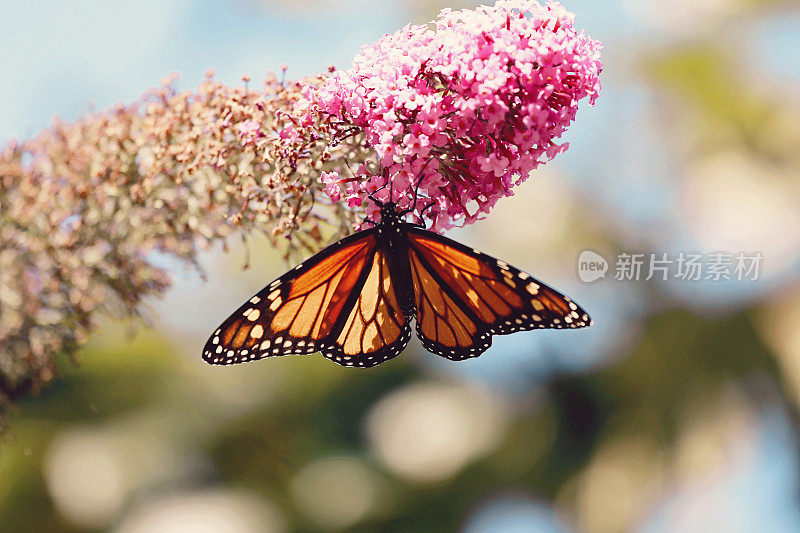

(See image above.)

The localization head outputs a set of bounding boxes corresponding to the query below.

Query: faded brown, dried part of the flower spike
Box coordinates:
[0,72,366,422]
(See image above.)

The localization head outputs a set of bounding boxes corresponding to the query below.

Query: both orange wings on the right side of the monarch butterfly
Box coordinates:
[408,227,591,360]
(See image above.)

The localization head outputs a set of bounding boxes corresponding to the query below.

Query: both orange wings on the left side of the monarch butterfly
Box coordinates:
[203,230,411,366]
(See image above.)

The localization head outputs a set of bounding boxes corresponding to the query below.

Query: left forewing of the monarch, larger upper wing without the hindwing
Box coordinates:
[203,230,377,365]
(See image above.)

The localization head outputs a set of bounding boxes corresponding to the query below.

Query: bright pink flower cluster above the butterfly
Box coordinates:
[313,0,601,231]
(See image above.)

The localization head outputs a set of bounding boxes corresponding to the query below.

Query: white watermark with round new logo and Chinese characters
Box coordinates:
[578,250,764,283]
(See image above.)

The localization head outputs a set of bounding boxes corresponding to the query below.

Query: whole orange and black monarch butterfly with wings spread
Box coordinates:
[203,198,591,367]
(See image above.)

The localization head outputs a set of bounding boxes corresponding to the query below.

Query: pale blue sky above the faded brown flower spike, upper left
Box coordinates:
[0,0,408,143]
